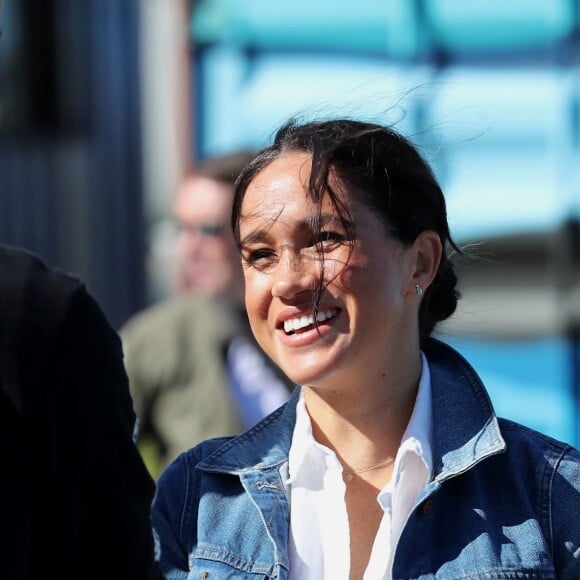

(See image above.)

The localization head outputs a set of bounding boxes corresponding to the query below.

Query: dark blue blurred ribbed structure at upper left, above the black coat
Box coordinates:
[0,0,144,325]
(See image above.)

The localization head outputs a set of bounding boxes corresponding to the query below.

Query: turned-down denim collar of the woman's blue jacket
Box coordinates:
[197,338,506,485]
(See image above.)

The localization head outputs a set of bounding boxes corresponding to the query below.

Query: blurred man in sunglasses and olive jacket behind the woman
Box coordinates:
[120,152,293,476]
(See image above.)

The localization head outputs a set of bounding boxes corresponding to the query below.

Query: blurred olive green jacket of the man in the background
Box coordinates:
[120,294,290,476]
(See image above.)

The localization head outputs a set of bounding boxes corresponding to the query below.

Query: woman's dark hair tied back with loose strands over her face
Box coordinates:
[232,119,462,339]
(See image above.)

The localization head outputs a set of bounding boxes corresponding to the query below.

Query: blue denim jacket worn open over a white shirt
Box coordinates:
[153,339,580,580]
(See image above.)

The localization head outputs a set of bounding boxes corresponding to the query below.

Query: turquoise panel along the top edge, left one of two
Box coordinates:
[192,0,422,56]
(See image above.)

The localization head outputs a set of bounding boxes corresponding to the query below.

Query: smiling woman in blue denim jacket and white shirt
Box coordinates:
[153,120,580,580]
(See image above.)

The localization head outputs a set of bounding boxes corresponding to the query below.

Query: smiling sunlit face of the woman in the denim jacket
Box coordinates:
[240,153,418,388]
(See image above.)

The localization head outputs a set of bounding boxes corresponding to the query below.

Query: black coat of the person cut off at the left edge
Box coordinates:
[0,245,159,580]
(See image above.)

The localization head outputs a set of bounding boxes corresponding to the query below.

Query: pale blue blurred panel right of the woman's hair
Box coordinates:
[431,68,577,239]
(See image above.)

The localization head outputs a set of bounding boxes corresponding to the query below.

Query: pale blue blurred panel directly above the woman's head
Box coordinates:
[198,47,429,154]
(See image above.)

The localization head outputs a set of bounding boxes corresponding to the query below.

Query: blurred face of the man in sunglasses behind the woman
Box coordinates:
[173,177,243,301]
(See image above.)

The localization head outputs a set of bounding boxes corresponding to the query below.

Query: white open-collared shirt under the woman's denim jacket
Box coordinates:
[288,354,432,580]
